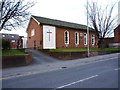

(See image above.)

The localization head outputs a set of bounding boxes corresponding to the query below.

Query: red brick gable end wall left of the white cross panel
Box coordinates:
[27,18,42,48]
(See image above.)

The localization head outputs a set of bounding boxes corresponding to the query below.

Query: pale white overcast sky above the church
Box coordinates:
[1,0,118,36]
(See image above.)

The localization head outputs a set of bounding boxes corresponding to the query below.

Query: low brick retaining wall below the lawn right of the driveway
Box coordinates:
[47,51,118,60]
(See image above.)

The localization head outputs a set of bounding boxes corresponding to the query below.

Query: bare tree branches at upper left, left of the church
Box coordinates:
[0,0,35,31]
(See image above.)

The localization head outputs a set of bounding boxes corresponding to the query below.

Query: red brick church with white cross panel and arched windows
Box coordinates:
[26,16,98,49]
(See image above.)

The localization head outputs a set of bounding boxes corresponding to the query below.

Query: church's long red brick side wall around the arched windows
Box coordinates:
[56,27,98,48]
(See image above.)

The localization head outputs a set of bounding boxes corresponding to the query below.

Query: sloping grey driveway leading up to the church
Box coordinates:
[26,49,60,65]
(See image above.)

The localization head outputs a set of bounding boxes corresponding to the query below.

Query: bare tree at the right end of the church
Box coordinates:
[88,2,117,46]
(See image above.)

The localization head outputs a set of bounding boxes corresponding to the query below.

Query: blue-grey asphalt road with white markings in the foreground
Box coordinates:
[2,57,120,89]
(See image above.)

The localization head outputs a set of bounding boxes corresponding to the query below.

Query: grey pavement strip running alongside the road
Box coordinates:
[0,50,120,80]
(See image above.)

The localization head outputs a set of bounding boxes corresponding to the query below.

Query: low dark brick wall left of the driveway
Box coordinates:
[2,54,32,68]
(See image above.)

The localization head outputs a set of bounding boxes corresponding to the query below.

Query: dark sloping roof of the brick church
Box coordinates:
[32,16,94,31]
